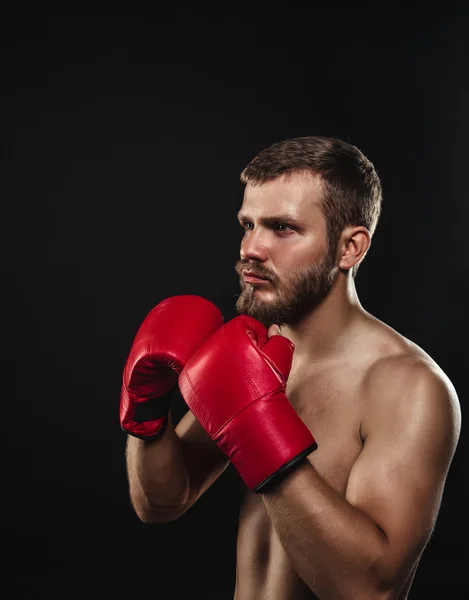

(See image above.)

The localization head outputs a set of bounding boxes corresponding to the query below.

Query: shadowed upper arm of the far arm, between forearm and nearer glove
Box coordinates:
[175,410,229,505]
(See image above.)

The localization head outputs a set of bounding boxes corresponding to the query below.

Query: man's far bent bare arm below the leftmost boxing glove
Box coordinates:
[126,411,229,523]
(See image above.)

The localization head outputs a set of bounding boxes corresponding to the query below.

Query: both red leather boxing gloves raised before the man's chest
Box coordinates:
[120,295,317,492]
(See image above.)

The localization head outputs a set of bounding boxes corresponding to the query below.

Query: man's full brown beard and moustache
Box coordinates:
[235,250,338,327]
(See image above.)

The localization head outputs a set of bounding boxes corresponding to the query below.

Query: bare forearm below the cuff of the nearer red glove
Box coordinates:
[263,462,390,599]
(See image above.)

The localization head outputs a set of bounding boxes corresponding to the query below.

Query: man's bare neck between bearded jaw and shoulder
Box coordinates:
[280,274,365,366]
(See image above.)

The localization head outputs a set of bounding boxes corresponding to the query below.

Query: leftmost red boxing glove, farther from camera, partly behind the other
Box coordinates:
[120,295,223,440]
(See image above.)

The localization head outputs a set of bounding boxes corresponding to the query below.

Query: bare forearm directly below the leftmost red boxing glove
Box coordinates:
[126,420,189,523]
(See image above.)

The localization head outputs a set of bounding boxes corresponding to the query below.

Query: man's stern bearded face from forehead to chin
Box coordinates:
[236,173,338,327]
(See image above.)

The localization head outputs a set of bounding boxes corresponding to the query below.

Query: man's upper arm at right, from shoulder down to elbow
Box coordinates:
[346,374,459,579]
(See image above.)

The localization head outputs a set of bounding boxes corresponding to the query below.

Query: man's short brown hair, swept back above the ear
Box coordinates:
[241,136,382,277]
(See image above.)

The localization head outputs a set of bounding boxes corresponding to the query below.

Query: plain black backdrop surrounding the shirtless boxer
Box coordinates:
[4,10,469,600]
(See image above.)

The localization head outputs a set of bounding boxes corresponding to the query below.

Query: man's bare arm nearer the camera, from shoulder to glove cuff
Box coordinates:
[262,359,461,599]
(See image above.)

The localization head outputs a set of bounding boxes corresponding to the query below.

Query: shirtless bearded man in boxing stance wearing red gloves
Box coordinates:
[121,137,461,600]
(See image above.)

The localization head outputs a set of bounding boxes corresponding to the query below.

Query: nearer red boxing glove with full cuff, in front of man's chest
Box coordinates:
[179,316,317,492]
